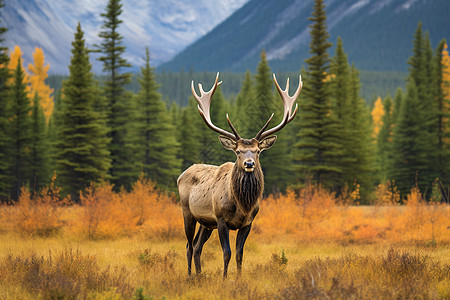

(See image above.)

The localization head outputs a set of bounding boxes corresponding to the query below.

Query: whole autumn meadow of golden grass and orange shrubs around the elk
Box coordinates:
[0,178,450,299]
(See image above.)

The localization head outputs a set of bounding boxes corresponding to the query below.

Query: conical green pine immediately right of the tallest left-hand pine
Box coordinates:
[137,48,180,188]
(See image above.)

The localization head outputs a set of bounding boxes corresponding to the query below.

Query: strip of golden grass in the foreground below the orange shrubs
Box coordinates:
[0,234,450,299]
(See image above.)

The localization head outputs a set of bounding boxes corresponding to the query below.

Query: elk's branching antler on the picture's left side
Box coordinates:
[191,72,241,141]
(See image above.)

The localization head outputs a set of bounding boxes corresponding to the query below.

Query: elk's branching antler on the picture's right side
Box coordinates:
[255,74,303,141]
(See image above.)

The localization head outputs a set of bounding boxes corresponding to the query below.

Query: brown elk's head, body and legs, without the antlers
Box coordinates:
[177,137,276,276]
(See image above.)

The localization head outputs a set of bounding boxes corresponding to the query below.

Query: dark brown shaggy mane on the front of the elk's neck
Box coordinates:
[231,164,264,213]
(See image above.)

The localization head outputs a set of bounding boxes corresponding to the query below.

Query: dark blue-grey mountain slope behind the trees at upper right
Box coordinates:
[159,0,450,72]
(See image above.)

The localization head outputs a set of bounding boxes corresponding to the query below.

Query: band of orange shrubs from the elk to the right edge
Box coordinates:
[254,183,450,244]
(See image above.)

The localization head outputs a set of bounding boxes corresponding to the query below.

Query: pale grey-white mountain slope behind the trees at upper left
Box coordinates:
[0,0,248,74]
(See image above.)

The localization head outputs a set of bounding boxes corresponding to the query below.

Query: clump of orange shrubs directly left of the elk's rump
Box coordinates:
[73,176,183,239]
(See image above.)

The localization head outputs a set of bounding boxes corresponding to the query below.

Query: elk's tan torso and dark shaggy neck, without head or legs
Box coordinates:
[178,162,264,229]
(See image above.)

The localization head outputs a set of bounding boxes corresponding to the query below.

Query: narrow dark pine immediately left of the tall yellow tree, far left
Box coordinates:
[10,58,31,200]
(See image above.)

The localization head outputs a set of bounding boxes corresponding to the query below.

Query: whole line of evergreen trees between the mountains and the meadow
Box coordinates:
[0,0,450,203]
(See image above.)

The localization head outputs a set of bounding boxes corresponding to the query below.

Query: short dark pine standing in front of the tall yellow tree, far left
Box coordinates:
[29,93,51,193]
